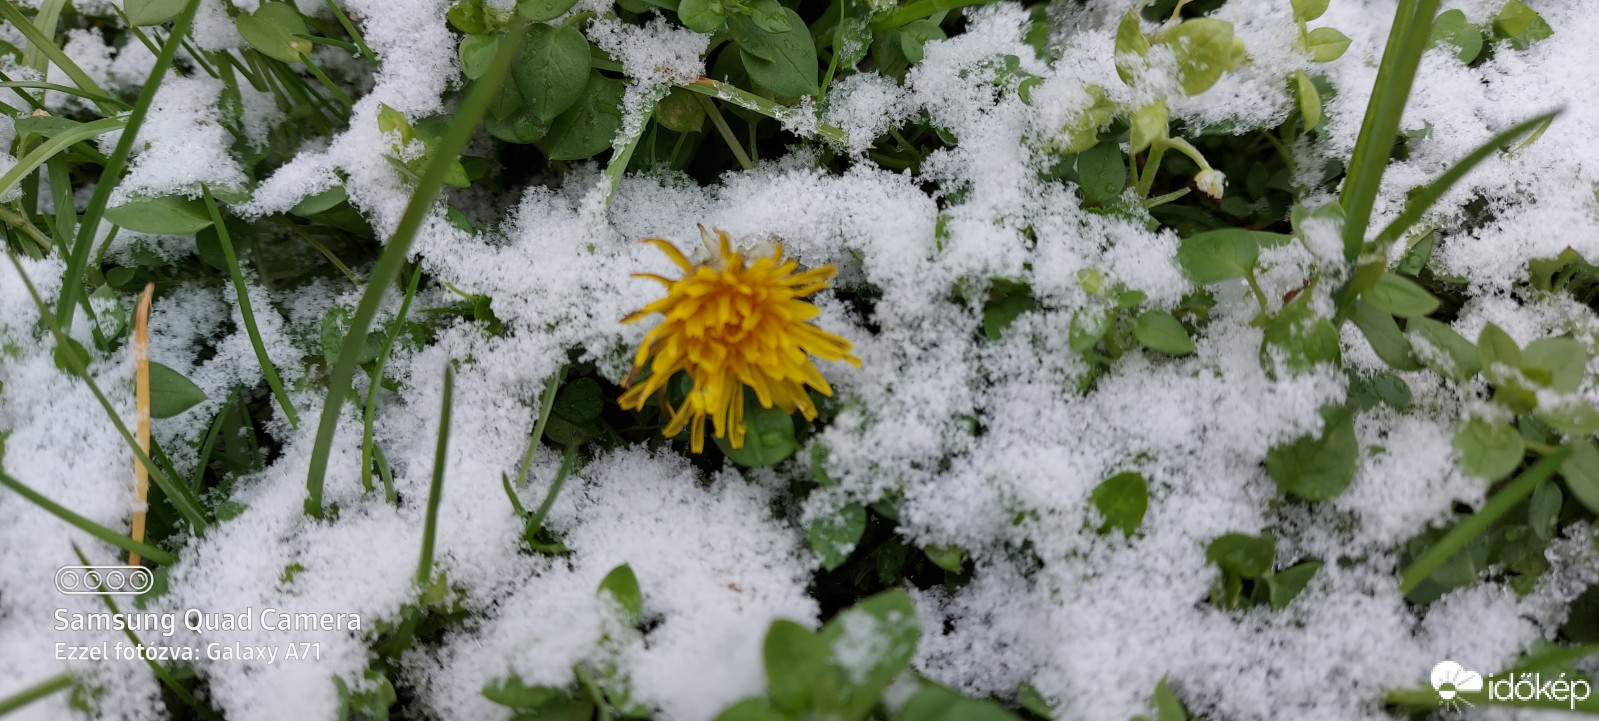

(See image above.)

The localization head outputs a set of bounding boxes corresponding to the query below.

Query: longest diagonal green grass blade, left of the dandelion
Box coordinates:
[305,19,528,518]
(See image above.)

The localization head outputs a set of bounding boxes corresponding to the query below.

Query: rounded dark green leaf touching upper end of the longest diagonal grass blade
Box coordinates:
[510,26,591,123]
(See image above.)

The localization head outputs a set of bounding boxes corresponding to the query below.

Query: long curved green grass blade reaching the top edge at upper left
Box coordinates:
[51,0,200,326]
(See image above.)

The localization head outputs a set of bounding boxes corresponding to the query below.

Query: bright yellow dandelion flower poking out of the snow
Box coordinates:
[620,225,860,452]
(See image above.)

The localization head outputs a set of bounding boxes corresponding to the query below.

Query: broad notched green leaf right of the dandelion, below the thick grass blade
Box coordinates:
[1266,404,1359,500]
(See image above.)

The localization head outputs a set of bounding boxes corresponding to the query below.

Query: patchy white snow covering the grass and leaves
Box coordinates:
[0,0,1599,721]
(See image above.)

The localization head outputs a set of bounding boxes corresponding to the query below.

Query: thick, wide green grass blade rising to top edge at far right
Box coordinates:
[1338,0,1438,262]
